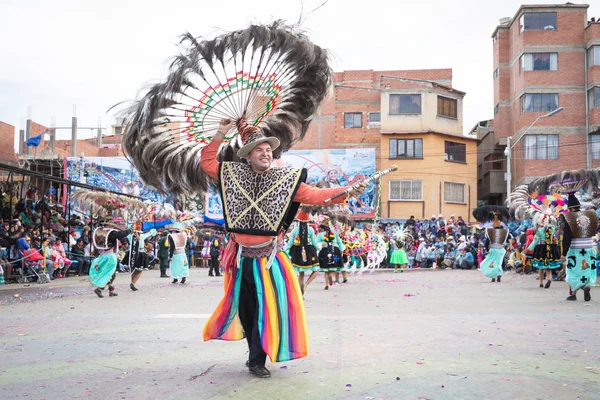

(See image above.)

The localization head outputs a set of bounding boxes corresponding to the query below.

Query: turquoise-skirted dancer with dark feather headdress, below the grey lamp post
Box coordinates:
[473,206,508,282]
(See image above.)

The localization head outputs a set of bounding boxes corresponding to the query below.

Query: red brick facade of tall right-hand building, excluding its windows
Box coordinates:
[493,6,587,183]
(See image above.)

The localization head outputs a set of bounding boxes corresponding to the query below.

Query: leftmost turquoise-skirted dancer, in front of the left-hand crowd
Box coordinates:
[90,224,131,297]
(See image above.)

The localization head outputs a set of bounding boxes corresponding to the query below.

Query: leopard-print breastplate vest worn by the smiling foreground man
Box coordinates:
[219,162,307,236]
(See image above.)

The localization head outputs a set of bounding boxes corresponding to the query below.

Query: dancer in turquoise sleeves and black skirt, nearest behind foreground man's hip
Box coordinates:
[284,207,319,294]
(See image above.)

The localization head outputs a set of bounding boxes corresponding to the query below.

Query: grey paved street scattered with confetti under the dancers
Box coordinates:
[0,269,600,400]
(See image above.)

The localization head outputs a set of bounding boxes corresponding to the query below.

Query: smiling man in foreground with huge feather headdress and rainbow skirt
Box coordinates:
[123,22,366,378]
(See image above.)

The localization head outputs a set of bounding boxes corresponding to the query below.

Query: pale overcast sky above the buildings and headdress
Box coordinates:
[0,0,600,147]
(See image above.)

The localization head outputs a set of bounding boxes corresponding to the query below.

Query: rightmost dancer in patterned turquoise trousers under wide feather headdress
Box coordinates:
[529,170,598,301]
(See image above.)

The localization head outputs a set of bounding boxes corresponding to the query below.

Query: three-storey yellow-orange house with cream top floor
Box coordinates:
[380,78,477,221]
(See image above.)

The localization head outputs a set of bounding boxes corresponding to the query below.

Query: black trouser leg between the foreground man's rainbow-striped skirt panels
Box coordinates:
[238,258,267,367]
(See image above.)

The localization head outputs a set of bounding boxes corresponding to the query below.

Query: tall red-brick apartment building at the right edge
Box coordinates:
[480,3,600,201]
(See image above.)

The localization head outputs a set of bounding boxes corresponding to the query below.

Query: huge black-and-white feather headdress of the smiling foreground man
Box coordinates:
[123,21,332,198]
